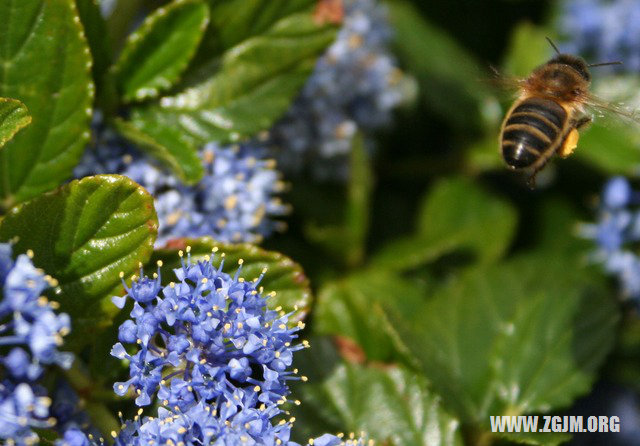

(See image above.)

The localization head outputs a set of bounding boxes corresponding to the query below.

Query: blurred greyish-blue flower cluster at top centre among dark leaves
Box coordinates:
[271,0,404,174]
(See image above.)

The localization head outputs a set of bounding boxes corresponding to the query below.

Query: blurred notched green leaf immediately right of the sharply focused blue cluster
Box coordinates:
[314,270,426,362]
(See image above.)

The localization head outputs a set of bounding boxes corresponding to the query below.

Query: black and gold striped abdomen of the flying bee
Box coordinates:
[501,97,567,169]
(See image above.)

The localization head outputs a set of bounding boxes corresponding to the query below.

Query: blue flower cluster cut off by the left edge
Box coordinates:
[0,243,73,444]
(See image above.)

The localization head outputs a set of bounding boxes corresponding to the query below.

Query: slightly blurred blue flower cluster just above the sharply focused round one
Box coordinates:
[75,123,289,245]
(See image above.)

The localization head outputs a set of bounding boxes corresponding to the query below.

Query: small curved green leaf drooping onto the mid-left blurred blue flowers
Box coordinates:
[114,118,204,184]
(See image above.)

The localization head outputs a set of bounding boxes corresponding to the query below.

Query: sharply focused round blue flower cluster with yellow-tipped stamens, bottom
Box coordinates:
[111,247,307,413]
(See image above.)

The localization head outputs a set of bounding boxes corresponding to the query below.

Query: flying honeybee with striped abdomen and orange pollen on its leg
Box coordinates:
[500,37,631,189]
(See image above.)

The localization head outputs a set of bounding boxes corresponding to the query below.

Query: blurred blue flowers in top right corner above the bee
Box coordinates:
[559,0,640,72]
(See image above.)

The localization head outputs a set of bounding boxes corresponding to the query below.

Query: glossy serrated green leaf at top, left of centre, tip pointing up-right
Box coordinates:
[114,0,209,101]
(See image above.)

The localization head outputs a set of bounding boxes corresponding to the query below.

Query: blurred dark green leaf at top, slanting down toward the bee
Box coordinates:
[388,0,491,131]
